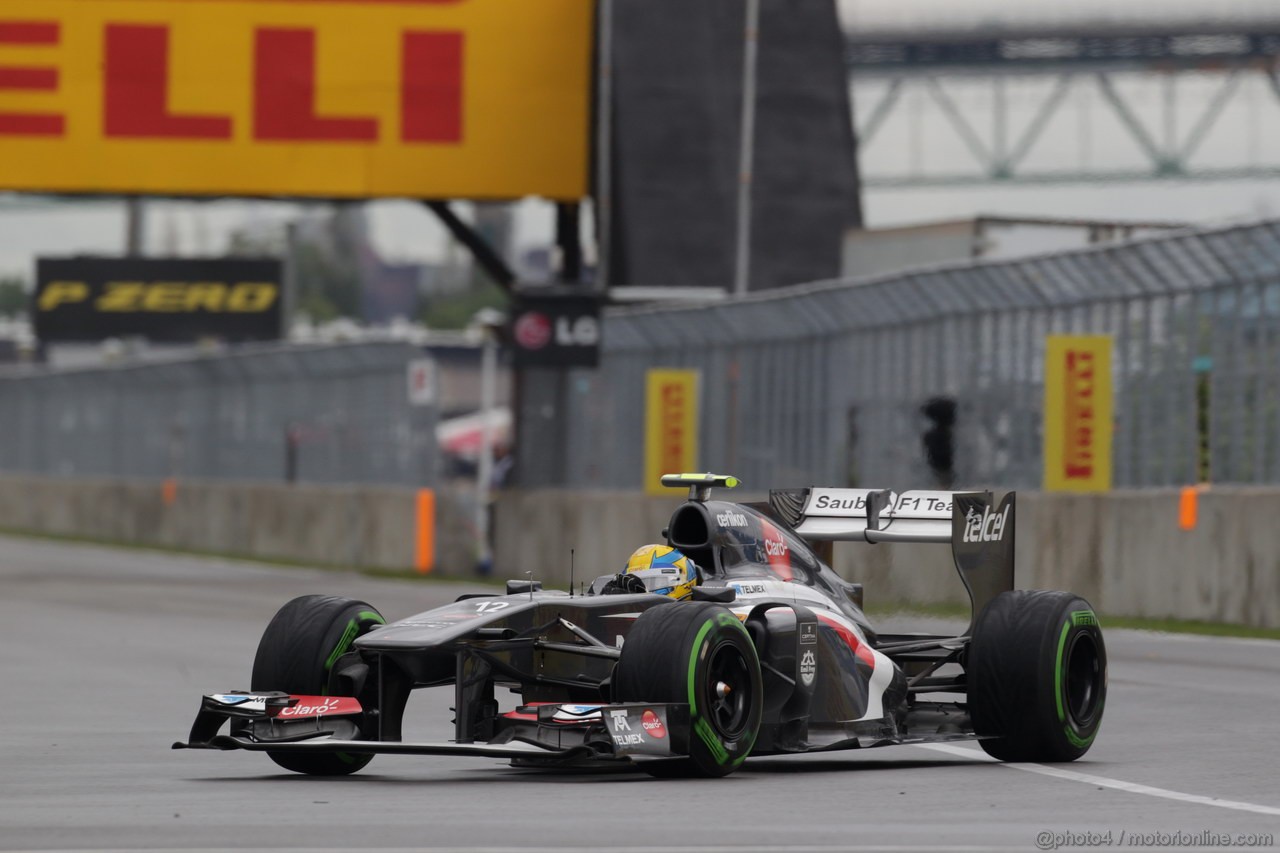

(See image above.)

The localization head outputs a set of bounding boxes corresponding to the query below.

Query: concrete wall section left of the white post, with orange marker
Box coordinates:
[0,475,476,575]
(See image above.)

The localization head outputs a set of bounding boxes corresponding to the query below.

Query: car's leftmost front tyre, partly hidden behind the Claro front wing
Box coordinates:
[250,596,385,776]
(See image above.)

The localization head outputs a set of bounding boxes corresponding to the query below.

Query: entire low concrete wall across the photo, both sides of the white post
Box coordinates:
[0,476,1280,628]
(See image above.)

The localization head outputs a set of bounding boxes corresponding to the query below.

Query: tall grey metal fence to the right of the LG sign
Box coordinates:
[562,216,1280,488]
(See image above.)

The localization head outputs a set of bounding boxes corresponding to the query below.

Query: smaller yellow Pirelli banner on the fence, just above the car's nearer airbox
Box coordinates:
[644,370,698,496]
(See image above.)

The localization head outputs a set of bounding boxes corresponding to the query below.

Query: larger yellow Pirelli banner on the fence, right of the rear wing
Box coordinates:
[1044,334,1112,492]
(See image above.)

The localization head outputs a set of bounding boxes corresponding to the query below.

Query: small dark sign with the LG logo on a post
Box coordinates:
[509,295,600,368]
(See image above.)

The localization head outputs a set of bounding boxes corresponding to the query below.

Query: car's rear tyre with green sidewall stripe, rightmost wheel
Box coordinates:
[965,589,1107,762]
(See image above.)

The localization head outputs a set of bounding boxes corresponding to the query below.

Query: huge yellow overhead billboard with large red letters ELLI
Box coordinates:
[0,0,593,200]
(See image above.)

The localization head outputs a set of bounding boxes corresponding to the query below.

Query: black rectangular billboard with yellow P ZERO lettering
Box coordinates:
[32,257,283,342]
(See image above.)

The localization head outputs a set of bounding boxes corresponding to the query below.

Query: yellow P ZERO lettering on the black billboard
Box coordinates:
[36,282,280,314]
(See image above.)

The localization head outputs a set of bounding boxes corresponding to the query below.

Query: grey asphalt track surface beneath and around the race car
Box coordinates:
[0,537,1280,853]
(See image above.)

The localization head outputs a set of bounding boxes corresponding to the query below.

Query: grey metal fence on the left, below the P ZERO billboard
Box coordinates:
[0,343,436,485]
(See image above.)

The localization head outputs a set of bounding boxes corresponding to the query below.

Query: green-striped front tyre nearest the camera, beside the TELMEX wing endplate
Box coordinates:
[613,602,764,776]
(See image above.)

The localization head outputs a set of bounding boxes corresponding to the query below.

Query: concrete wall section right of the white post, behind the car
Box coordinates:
[494,488,1280,628]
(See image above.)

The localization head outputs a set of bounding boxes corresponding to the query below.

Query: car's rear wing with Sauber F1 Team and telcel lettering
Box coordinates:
[769,488,1016,630]
